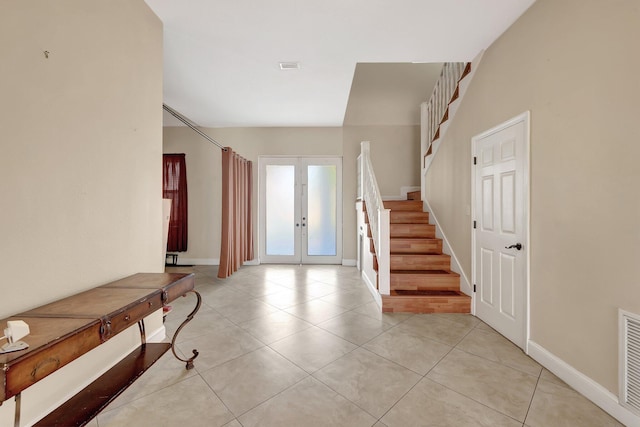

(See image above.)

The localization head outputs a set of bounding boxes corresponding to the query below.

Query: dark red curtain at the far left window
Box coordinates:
[162,154,188,252]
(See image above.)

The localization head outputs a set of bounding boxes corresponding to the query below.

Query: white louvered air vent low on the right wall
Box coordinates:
[618,310,640,415]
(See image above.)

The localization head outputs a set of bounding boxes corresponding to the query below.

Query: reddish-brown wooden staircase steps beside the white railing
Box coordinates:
[365,191,471,313]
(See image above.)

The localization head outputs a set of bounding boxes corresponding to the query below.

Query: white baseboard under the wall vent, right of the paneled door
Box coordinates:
[529,340,640,426]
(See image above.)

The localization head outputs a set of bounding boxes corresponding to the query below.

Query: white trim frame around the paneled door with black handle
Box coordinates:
[470,110,531,354]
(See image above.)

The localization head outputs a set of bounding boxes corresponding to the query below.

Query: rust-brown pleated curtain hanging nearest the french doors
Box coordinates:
[218,147,253,278]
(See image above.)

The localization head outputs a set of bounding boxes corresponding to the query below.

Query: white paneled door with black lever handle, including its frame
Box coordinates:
[472,113,529,350]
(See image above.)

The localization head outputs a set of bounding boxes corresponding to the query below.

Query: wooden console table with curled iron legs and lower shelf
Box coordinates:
[0,273,202,427]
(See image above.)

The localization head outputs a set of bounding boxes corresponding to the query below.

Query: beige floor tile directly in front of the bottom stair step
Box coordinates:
[398,314,472,346]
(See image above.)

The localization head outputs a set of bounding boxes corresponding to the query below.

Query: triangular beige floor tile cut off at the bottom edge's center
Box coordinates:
[238,377,376,427]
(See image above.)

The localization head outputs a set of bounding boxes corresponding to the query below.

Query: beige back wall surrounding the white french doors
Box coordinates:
[164,126,420,263]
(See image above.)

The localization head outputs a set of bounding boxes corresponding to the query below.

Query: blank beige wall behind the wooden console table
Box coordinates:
[0,0,163,318]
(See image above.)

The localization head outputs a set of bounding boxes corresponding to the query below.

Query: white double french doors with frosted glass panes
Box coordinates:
[258,157,342,264]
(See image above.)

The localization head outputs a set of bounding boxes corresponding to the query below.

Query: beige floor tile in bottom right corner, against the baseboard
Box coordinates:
[525,379,622,427]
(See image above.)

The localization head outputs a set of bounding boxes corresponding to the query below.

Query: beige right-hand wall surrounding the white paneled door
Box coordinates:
[427,0,640,394]
